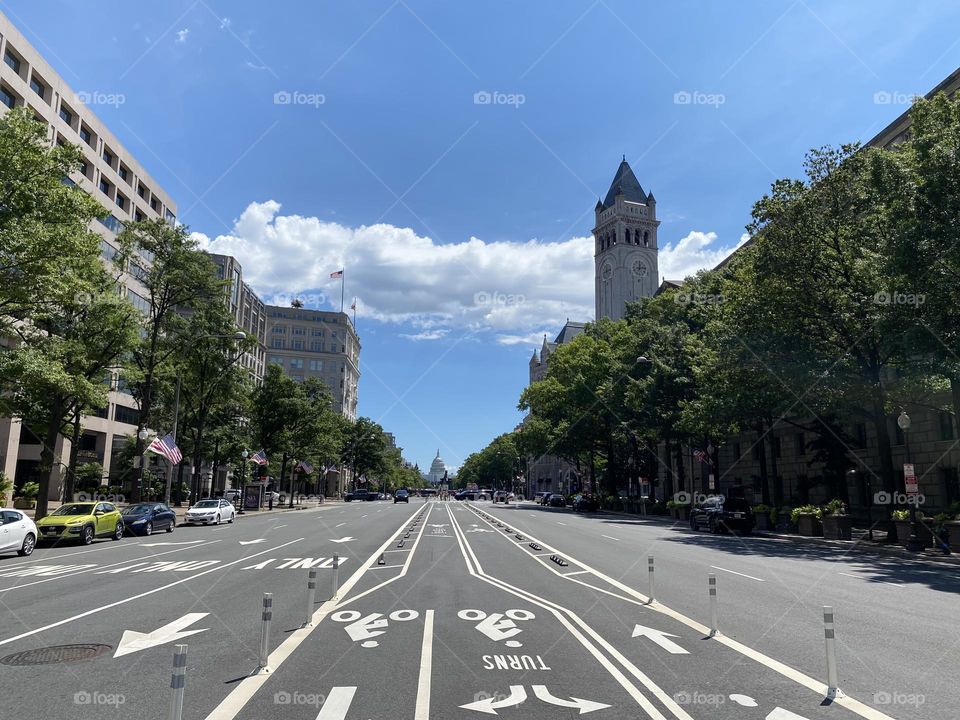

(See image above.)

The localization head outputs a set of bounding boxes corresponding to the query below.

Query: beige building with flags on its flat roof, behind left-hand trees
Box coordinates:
[266,305,360,420]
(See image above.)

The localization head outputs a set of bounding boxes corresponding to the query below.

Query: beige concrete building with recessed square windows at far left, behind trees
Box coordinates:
[0,14,177,499]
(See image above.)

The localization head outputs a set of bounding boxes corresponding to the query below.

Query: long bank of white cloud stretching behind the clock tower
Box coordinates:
[194,200,742,346]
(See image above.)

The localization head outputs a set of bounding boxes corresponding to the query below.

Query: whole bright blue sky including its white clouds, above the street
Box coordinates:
[9,0,960,467]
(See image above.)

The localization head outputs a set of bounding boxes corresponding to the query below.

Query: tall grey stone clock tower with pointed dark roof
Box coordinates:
[593,157,660,320]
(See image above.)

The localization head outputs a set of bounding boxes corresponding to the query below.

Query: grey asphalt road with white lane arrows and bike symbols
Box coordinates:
[0,500,948,720]
